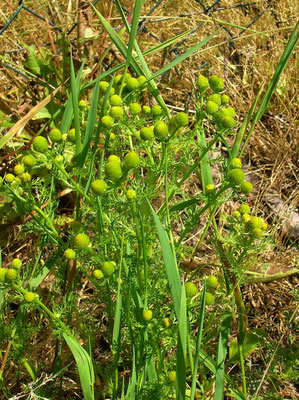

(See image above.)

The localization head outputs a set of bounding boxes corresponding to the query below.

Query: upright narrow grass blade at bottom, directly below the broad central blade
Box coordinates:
[176,285,187,400]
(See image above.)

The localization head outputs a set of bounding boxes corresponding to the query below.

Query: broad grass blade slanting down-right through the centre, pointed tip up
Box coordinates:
[149,203,182,319]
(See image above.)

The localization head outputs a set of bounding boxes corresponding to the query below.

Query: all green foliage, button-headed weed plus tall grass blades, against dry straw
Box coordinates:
[0,1,295,400]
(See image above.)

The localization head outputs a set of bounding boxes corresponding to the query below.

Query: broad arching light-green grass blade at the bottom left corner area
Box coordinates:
[63,333,94,400]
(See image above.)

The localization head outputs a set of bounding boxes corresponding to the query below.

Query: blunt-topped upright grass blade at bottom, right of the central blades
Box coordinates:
[214,313,232,400]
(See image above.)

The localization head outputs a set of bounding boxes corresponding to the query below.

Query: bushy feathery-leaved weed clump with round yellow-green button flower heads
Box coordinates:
[0,65,276,399]
